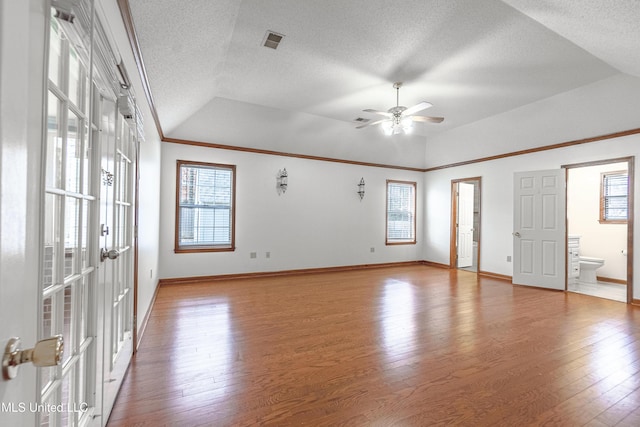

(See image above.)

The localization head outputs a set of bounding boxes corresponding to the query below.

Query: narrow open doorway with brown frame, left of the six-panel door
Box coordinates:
[449,177,482,273]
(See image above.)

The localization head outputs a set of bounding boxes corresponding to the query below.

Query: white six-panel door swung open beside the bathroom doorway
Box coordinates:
[513,169,566,290]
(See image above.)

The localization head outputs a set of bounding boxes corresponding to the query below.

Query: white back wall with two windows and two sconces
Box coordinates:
[160,143,424,278]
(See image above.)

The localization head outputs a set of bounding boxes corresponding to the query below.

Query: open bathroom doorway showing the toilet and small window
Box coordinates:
[563,157,634,303]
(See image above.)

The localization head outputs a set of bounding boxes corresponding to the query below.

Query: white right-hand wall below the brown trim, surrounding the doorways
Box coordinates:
[424,135,640,299]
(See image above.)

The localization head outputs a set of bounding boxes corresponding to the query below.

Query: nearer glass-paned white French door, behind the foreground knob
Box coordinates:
[38,20,99,426]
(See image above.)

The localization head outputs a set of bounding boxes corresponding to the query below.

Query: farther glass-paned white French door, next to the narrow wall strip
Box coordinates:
[98,98,135,425]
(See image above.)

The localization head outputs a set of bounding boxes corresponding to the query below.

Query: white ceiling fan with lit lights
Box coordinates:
[356,82,444,135]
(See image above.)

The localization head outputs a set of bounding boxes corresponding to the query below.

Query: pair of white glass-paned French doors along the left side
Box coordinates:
[38,6,137,426]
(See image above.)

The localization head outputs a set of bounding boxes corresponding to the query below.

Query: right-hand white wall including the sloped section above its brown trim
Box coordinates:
[425,74,640,298]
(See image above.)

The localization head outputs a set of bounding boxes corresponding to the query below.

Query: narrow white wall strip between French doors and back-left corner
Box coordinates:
[99,0,161,328]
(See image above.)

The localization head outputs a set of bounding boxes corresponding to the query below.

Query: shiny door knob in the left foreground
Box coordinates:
[2,335,64,380]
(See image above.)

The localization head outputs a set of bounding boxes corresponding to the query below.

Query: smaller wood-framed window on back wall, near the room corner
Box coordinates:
[386,180,416,245]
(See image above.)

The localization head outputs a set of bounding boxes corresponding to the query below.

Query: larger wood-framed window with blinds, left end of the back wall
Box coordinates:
[175,160,236,252]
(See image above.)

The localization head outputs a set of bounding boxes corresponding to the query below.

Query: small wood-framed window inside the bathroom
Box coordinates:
[600,171,629,224]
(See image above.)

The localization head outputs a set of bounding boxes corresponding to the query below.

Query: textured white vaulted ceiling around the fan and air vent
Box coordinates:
[130,0,640,162]
